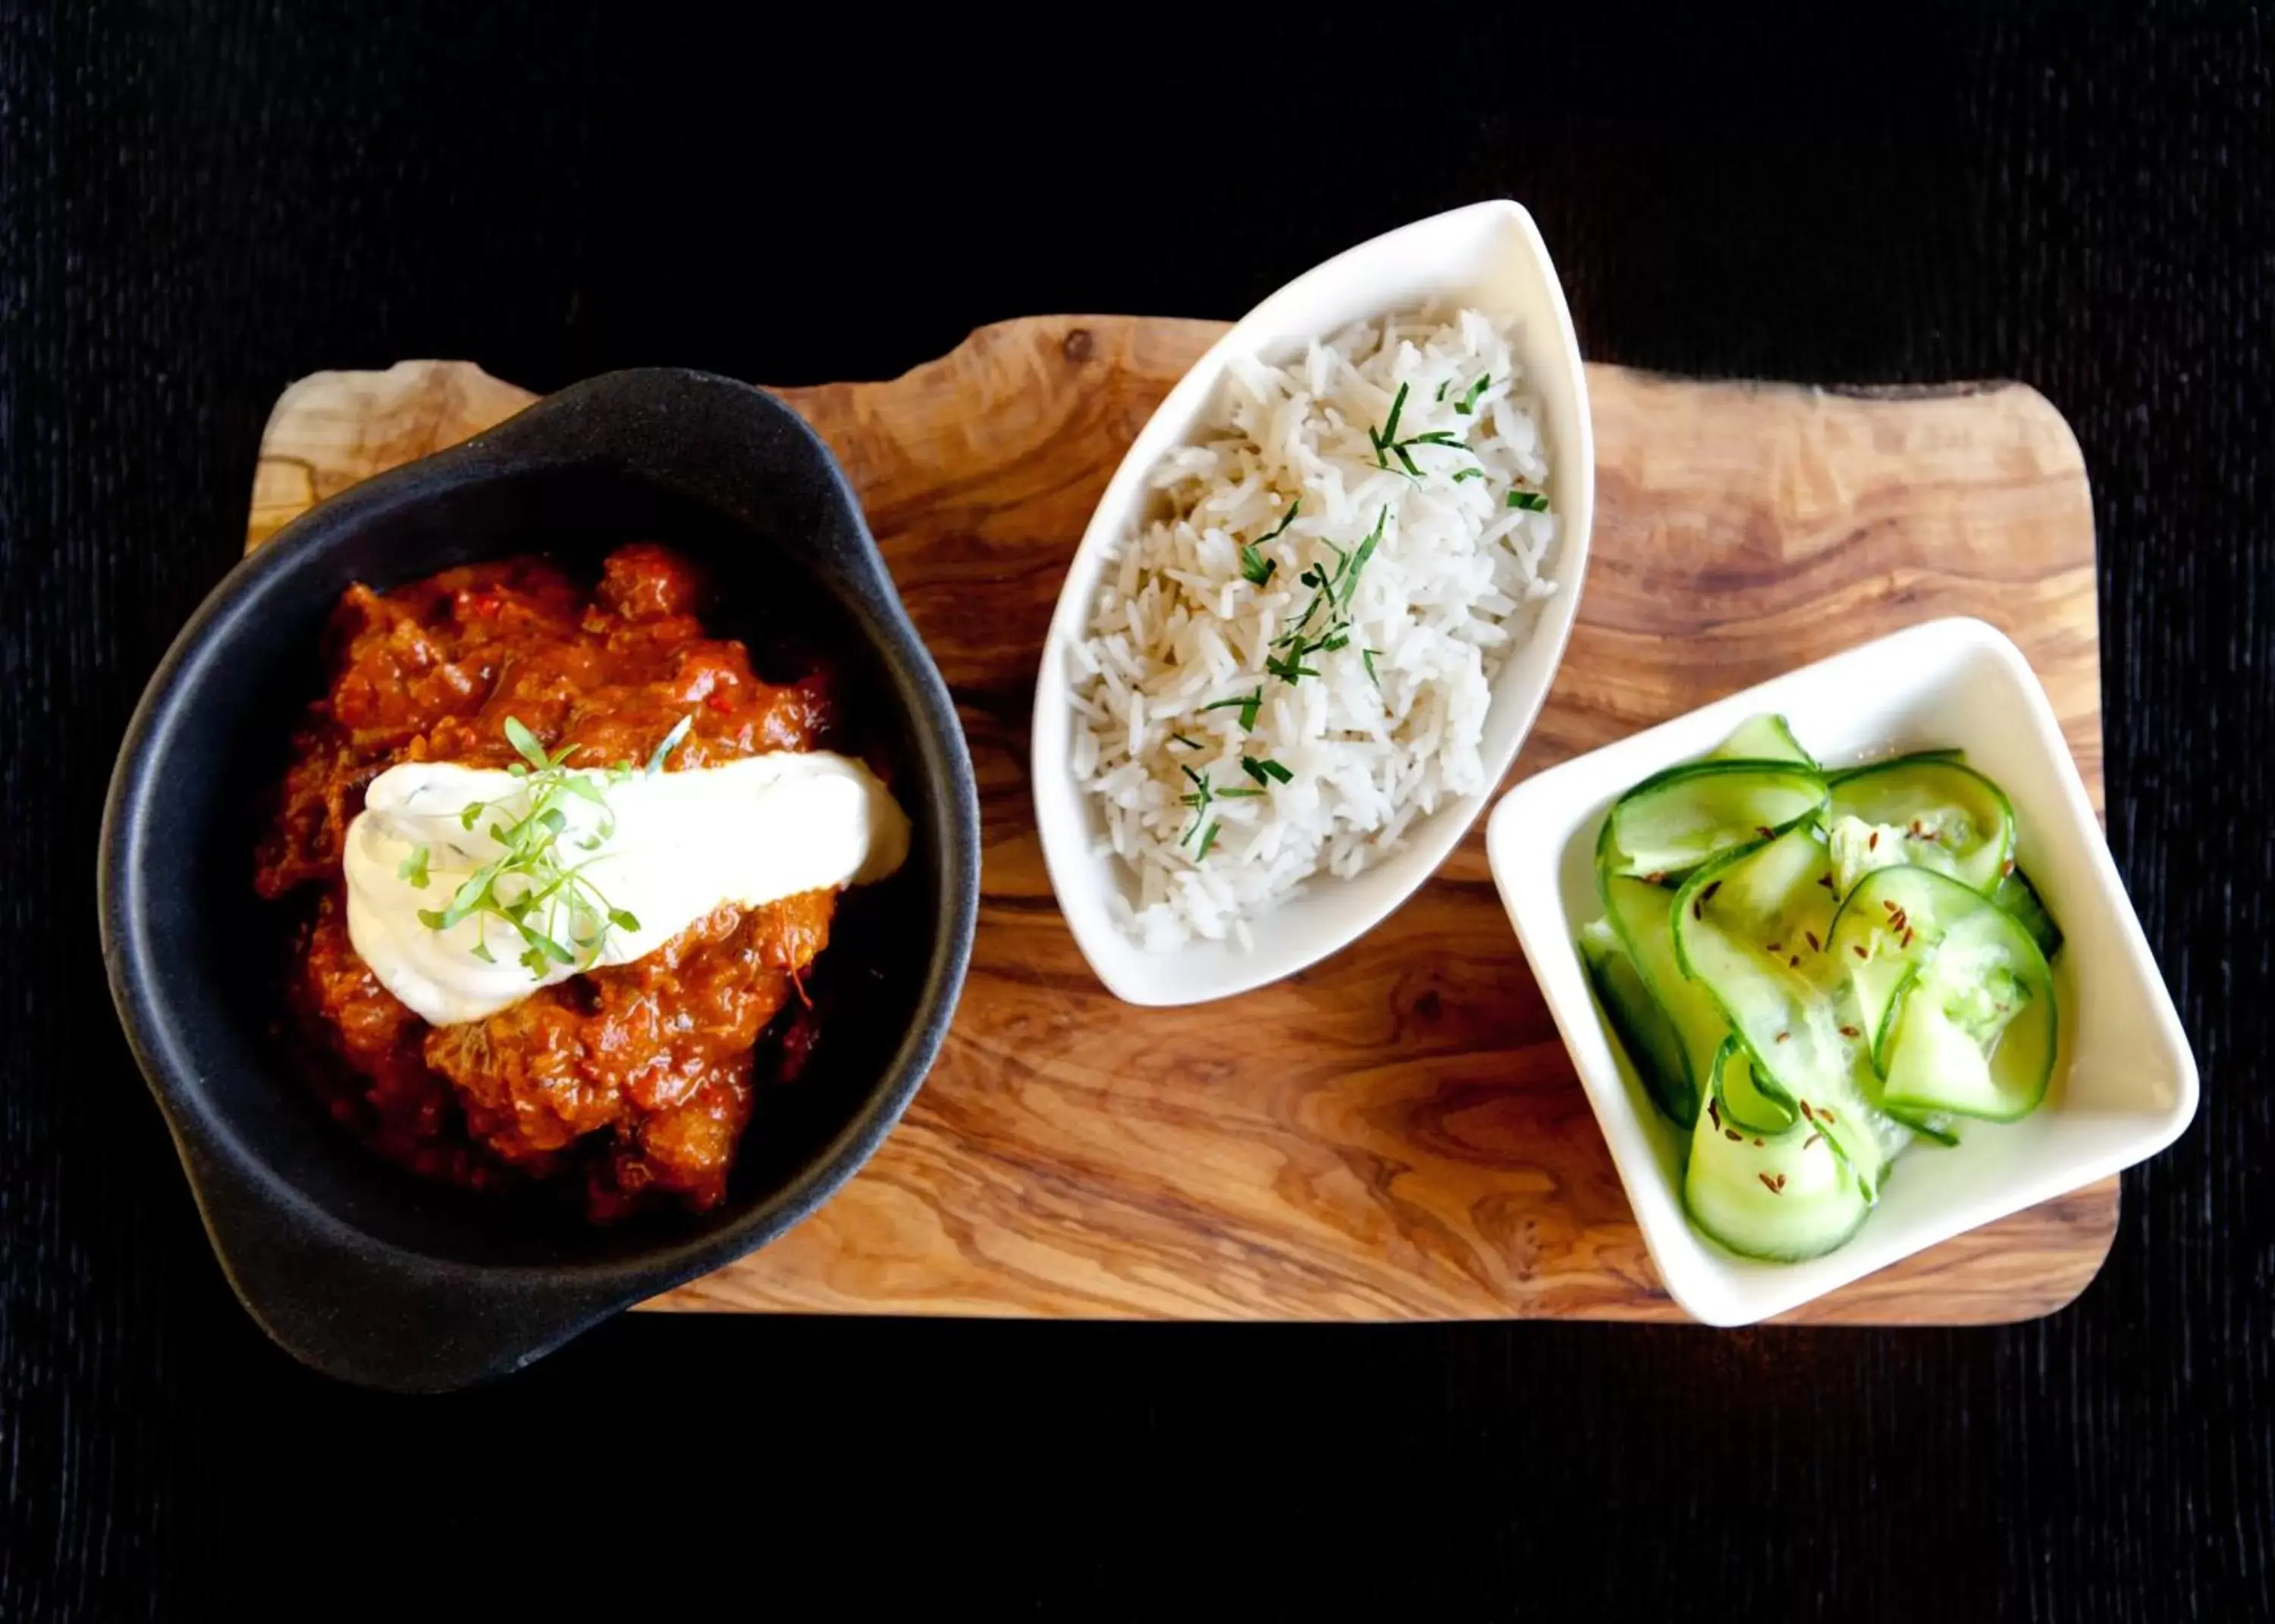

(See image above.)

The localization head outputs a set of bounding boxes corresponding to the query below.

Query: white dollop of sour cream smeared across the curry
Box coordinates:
[344,751,908,1026]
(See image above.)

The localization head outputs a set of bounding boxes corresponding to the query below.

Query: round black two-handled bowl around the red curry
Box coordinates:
[100,371,978,1390]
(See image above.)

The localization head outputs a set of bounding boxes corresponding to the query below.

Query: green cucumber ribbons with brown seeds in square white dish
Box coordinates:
[1579,716,2061,1262]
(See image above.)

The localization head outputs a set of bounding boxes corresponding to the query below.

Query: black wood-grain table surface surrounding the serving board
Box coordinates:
[0,2,2275,1619]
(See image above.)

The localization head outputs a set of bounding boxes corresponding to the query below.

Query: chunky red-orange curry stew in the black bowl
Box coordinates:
[255,544,855,1219]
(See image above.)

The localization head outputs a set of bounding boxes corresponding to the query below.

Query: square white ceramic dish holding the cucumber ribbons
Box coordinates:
[1486,619,2195,1326]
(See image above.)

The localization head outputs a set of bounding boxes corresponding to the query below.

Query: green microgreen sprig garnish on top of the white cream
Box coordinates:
[400,714,694,980]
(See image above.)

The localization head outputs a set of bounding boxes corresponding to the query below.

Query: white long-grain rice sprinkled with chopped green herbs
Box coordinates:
[1074,309,1556,948]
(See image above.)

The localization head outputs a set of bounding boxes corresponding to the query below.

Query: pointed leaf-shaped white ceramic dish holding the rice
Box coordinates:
[1033,200,1595,1005]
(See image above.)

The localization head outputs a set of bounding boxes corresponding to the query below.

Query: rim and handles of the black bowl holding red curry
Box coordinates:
[96,368,981,1390]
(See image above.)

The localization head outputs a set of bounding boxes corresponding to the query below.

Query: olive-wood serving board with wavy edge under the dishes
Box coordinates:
[248,316,2118,1324]
